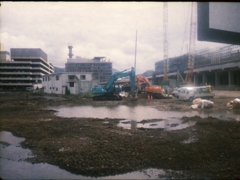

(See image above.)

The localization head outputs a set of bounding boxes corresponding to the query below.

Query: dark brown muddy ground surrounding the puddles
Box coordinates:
[0,92,240,179]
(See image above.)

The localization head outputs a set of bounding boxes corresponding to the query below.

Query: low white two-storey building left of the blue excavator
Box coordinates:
[42,72,97,94]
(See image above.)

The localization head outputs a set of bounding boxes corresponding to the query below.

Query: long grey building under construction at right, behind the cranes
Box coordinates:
[153,45,240,90]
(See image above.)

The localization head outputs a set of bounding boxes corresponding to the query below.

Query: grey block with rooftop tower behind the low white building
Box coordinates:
[65,45,112,84]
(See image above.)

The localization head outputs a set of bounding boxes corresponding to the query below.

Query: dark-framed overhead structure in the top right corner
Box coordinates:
[197,2,240,45]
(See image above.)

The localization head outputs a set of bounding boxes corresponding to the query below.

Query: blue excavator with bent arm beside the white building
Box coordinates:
[91,67,136,101]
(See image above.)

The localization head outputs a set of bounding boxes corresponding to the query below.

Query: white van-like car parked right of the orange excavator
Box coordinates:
[178,86,215,101]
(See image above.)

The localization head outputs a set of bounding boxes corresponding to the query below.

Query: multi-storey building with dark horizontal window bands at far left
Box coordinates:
[0,48,54,90]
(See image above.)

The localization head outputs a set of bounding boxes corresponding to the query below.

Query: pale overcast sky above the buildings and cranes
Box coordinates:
[0,2,229,74]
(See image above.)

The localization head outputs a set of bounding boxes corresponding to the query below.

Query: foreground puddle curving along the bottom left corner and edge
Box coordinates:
[0,131,185,179]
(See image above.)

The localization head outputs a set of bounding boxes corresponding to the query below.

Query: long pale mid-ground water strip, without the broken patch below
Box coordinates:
[49,105,240,122]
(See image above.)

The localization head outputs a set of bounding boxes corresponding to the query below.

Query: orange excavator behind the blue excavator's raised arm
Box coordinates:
[136,76,165,98]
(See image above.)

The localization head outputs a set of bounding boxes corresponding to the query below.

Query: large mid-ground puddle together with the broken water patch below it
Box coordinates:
[50,105,240,130]
